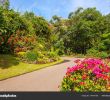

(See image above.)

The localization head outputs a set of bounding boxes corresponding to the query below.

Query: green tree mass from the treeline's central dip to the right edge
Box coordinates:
[50,8,110,58]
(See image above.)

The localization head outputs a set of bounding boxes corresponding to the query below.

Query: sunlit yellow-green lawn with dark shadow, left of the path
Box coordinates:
[0,55,63,80]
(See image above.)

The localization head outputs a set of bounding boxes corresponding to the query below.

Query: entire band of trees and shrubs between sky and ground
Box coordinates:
[0,0,110,63]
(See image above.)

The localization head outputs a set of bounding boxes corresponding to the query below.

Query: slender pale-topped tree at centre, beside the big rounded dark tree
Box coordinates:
[50,15,67,54]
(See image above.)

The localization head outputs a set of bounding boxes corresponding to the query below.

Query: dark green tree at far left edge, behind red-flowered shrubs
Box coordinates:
[0,8,29,53]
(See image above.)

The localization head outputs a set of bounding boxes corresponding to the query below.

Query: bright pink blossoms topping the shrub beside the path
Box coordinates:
[67,58,110,77]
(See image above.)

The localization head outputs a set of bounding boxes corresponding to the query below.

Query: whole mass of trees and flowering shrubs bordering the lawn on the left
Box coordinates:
[0,2,60,63]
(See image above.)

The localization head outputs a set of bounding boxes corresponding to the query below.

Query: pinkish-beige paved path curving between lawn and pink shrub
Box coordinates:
[0,57,83,91]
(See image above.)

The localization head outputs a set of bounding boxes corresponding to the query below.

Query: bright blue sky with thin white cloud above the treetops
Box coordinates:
[10,0,110,20]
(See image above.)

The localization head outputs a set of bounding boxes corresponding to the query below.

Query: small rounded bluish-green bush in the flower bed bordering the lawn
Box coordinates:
[25,51,38,62]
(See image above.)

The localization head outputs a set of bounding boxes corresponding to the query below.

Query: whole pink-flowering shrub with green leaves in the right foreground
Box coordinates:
[61,58,110,92]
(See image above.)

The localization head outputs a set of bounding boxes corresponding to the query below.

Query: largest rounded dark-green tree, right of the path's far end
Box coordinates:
[68,8,104,54]
